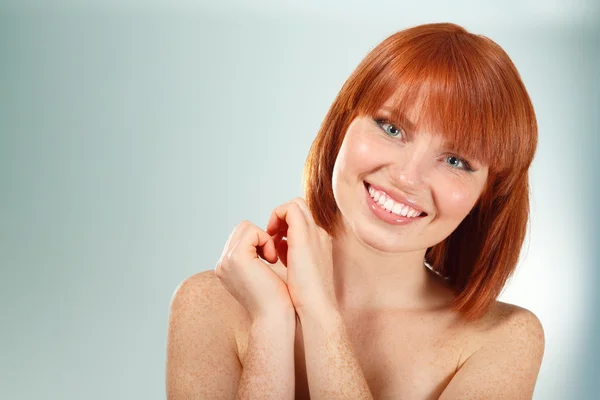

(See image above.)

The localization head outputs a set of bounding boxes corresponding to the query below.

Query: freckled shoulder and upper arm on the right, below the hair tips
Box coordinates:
[440,307,545,400]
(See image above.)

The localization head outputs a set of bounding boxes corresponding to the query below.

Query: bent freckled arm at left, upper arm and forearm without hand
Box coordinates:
[166,270,295,400]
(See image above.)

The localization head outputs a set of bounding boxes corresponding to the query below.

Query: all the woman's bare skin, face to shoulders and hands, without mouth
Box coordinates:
[167,97,544,400]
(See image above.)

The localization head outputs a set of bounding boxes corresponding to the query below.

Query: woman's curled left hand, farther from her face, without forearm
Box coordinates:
[215,221,294,321]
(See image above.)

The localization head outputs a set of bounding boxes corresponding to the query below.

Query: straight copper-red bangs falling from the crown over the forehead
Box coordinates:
[348,28,537,171]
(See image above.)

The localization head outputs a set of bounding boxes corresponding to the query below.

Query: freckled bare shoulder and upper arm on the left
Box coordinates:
[166,270,252,399]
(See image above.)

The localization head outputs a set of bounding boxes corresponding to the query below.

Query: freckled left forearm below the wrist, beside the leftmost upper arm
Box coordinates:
[236,311,296,400]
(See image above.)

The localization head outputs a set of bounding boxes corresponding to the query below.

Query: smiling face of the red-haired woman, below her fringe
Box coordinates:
[332,99,488,252]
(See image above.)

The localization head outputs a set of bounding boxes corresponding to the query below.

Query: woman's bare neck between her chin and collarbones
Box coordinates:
[332,225,450,311]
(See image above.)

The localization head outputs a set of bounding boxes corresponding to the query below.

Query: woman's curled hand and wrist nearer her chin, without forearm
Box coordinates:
[266,197,338,320]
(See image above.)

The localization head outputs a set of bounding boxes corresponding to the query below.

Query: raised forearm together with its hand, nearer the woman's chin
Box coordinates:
[266,198,373,400]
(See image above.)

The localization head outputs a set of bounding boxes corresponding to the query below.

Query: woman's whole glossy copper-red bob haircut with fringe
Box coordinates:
[303,23,537,319]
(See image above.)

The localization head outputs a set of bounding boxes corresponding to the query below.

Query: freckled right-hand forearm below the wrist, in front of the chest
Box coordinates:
[300,311,373,400]
